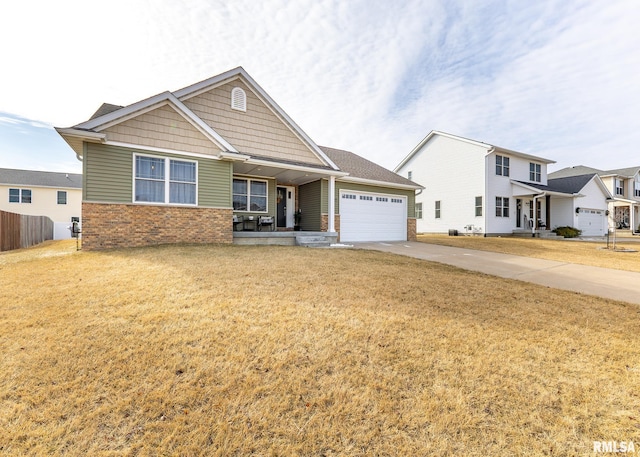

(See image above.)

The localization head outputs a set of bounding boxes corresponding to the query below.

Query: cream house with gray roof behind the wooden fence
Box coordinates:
[0,168,82,240]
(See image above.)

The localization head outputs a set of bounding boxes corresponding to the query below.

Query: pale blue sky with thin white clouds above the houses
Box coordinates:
[0,0,640,173]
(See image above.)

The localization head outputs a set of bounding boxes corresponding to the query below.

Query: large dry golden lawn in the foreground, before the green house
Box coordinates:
[0,242,640,456]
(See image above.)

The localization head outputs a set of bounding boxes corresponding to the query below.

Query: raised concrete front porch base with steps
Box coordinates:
[233,230,338,247]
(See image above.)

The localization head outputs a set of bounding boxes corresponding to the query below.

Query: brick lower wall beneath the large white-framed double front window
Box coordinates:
[82,202,233,250]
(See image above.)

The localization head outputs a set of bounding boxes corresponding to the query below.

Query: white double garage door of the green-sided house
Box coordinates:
[339,190,407,241]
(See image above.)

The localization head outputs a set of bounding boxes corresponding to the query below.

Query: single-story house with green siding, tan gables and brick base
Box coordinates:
[56,67,420,249]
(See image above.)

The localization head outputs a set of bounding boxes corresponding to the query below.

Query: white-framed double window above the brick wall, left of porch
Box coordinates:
[134,155,197,205]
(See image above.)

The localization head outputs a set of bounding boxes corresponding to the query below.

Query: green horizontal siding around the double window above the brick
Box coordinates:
[83,143,233,208]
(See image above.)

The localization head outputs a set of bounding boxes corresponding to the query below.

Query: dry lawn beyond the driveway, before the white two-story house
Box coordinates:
[418,234,640,272]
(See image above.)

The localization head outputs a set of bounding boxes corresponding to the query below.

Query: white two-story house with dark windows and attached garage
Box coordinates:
[394,131,610,236]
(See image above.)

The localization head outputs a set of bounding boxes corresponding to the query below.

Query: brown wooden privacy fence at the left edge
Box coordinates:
[0,211,53,251]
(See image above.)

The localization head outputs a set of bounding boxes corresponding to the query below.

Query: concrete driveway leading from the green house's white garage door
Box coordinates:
[353,241,640,304]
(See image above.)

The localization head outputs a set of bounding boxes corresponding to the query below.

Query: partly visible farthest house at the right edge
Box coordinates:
[549,165,640,233]
